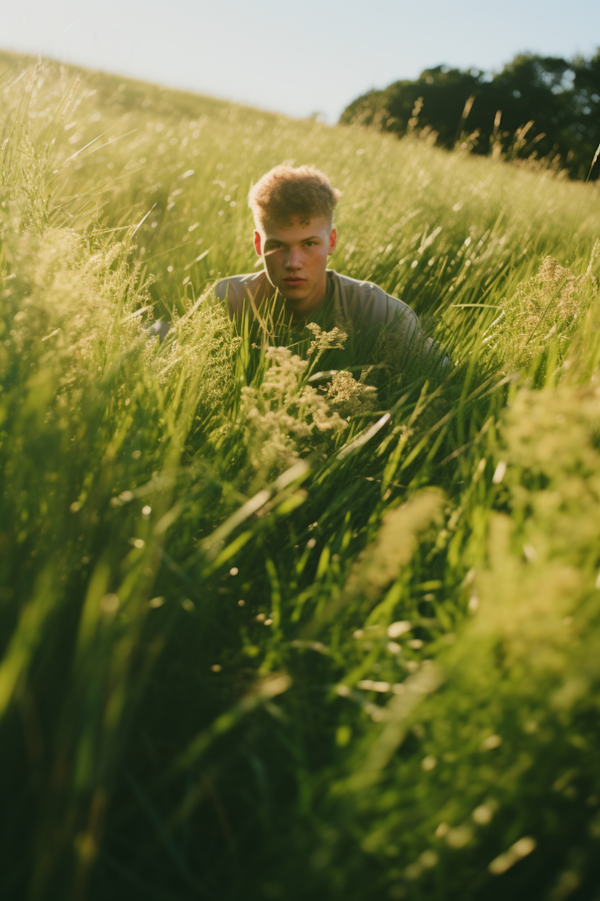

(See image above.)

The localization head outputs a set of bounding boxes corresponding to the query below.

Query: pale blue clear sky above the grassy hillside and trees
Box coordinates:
[0,0,600,123]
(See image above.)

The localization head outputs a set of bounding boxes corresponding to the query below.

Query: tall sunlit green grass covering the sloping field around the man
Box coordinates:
[0,54,600,901]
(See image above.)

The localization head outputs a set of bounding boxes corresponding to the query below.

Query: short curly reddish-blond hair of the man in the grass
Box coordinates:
[248,166,342,225]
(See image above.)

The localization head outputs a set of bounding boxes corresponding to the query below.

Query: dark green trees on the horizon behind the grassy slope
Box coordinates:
[340,47,600,179]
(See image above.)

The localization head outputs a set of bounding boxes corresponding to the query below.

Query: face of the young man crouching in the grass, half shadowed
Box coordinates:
[254,216,337,317]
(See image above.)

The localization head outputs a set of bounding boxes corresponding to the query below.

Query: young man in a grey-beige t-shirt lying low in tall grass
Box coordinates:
[215,166,437,370]
